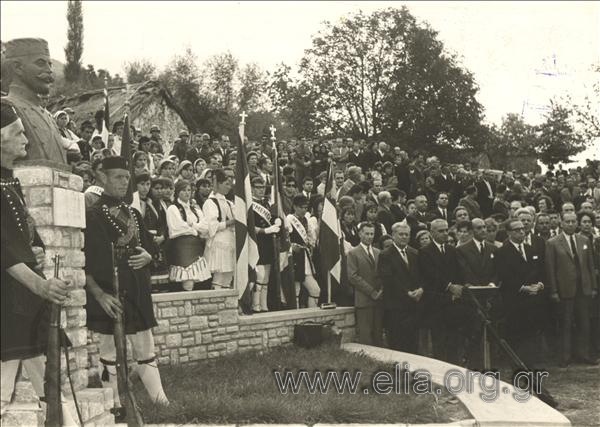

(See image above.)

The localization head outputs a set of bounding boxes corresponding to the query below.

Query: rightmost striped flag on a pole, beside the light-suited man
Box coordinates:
[319,161,342,302]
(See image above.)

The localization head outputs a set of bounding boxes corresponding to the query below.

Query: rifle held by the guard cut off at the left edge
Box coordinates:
[44,254,63,427]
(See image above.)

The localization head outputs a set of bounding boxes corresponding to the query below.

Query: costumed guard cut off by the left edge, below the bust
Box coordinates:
[0,100,76,425]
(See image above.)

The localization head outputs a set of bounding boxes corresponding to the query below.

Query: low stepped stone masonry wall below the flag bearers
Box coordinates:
[90,290,355,372]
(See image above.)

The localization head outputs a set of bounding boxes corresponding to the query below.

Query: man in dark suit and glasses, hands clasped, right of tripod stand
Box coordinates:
[495,219,545,368]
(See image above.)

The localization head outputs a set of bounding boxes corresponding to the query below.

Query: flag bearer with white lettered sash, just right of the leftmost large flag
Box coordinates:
[250,176,281,313]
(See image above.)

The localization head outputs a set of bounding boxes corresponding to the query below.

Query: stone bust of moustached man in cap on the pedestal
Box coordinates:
[3,38,67,164]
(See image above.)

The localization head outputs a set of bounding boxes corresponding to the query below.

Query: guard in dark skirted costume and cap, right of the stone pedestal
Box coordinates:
[84,156,169,416]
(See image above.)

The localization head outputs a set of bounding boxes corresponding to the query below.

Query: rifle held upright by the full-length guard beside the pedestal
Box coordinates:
[111,243,144,427]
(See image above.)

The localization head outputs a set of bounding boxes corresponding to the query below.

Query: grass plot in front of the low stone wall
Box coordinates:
[134,347,470,424]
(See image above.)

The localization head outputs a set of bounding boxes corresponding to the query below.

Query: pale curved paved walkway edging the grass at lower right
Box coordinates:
[342,343,571,427]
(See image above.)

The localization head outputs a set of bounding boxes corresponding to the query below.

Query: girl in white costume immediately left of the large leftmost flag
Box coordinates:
[202,169,236,289]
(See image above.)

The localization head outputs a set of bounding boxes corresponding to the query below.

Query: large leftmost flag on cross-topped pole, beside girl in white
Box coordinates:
[233,122,258,311]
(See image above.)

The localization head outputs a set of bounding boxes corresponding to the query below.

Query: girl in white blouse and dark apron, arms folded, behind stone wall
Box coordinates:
[167,179,211,291]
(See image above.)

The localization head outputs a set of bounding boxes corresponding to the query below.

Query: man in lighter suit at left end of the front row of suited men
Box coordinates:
[347,222,383,347]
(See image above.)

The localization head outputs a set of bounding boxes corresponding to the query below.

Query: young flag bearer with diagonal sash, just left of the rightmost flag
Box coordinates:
[287,195,321,307]
